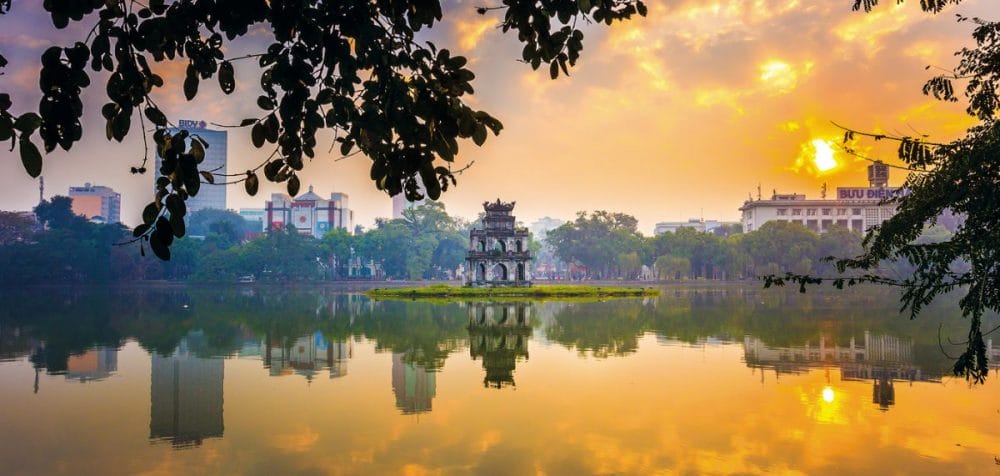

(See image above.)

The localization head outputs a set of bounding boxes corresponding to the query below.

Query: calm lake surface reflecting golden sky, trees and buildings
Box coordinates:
[0,286,1000,475]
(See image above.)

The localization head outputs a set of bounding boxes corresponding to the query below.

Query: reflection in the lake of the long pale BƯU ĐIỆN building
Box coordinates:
[743,331,941,411]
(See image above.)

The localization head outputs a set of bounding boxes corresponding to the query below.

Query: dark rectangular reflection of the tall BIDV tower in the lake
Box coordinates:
[149,336,225,447]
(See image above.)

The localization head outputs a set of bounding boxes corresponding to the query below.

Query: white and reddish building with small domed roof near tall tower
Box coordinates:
[264,186,354,238]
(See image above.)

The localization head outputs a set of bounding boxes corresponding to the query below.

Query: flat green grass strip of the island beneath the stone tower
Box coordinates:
[365,284,660,299]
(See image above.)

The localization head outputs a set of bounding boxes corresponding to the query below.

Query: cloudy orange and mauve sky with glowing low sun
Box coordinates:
[0,0,995,234]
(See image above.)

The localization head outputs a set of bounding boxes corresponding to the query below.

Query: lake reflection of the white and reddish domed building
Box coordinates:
[260,331,354,381]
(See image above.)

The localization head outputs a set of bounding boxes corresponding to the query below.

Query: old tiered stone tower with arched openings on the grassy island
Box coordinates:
[465,198,531,286]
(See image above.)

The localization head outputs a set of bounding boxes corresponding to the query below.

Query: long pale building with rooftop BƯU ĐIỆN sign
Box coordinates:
[740,162,908,233]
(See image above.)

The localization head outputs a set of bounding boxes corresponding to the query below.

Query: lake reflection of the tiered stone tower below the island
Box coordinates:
[468,303,532,388]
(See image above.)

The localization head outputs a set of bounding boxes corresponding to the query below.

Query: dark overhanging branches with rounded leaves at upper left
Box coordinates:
[0,0,646,259]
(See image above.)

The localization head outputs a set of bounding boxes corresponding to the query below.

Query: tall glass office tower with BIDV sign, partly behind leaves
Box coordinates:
[153,119,227,214]
